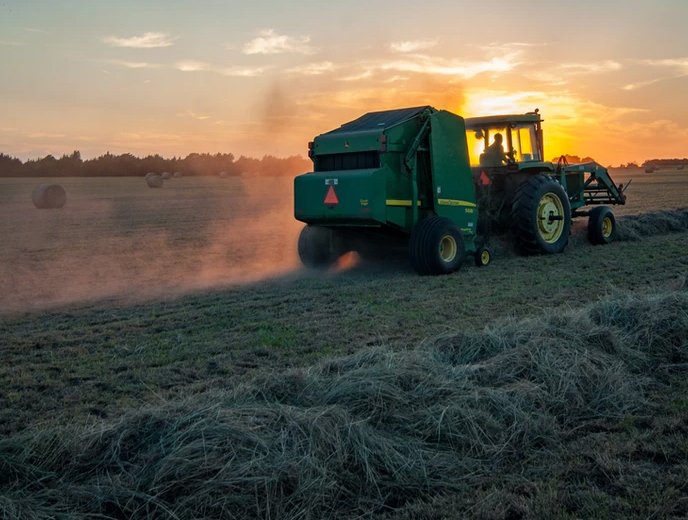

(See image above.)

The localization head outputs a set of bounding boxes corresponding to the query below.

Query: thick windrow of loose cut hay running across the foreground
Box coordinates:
[0,290,688,519]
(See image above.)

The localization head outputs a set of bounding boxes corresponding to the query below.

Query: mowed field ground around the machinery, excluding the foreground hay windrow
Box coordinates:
[0,172,688,518]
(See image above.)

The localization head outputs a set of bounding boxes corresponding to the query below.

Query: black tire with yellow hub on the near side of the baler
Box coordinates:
[409,216,465,275]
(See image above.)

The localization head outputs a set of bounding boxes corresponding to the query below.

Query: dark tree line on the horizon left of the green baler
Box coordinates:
[0,150,312,177]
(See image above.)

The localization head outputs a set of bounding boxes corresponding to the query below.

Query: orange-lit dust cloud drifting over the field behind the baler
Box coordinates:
[0,178,302,314]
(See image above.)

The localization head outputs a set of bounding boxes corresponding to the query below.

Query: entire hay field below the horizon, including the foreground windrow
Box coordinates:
[0,170,688,518]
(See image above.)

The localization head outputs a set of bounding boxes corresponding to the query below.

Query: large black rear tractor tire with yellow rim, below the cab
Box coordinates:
[511,174,571,255]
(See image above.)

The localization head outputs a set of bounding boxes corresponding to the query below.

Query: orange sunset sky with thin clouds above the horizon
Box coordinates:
[0,0,688,165]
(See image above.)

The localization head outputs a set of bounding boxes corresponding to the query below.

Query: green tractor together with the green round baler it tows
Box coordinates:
[294,106,626,275]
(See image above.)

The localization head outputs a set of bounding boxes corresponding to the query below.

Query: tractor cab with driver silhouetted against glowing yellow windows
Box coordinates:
[465,110,544,169]
